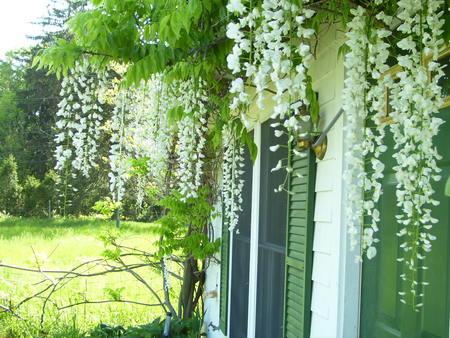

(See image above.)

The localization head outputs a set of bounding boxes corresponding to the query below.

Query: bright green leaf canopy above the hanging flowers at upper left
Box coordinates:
[35,0,230,85]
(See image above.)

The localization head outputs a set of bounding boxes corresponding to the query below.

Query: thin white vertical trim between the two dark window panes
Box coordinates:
[247,123,261,338]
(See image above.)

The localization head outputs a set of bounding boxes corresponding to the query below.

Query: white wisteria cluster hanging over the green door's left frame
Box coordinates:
[343,7,392,259]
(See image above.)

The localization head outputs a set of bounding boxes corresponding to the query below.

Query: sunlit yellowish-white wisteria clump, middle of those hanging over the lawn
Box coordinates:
[109,74,175,201]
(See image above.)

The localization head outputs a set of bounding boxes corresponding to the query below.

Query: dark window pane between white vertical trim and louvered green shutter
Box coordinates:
[256,121,287,338]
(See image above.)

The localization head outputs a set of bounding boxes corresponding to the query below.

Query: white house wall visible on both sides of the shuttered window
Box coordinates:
[205,27,357,338]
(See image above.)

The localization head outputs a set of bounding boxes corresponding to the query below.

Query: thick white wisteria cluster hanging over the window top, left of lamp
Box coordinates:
[227,0,315,176]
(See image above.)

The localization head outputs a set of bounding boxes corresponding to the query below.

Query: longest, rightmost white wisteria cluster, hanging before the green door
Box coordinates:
[390,0,444,310]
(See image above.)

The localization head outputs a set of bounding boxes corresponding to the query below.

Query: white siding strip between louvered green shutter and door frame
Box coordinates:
[311,25,347,338]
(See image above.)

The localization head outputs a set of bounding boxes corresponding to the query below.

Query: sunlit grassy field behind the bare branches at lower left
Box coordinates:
[0,218,176,337]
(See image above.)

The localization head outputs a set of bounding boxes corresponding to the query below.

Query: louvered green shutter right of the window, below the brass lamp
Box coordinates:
[284,150,316,338]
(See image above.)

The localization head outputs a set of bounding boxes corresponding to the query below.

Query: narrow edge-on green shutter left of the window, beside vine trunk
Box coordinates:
[219,213,230,334]
